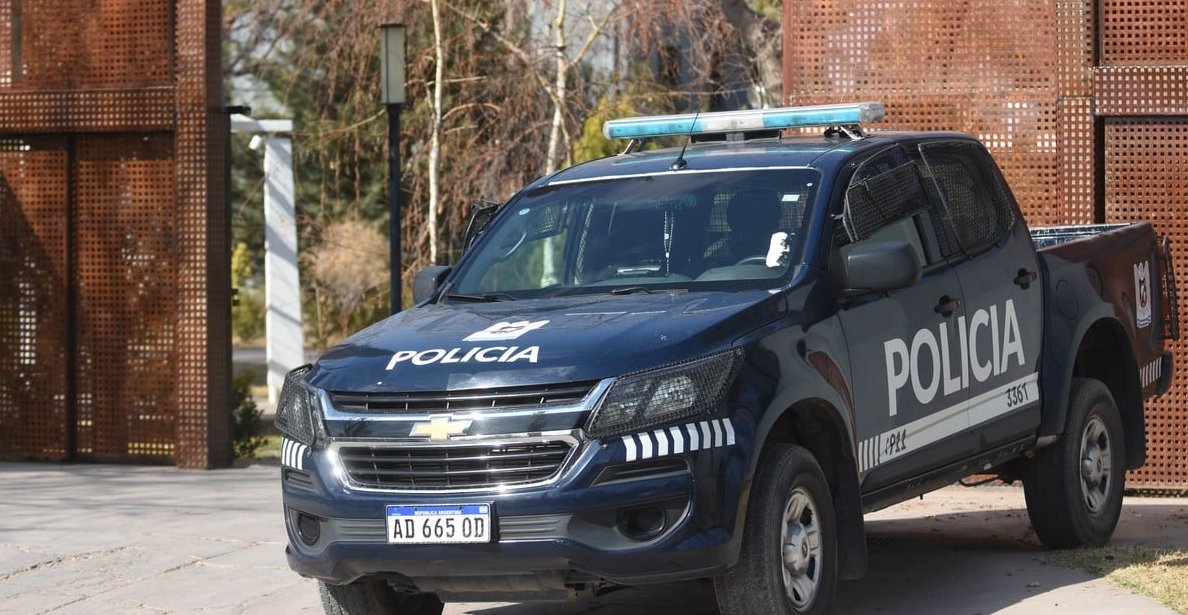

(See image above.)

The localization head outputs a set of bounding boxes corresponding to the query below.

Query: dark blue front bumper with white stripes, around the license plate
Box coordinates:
[282,419,751,600]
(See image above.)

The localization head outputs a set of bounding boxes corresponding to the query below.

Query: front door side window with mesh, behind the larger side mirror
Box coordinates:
[834,147,928,262]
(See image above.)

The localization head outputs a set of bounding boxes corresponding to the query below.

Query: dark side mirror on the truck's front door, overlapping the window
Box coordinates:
[838,241,922,299]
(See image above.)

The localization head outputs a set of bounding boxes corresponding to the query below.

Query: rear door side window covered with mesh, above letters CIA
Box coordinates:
[920,141,1015,256]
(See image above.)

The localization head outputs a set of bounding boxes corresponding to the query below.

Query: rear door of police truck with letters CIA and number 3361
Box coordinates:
[920,140,1043,446]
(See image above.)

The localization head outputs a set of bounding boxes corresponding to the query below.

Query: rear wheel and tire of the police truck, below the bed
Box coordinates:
[1023,378,1126,549]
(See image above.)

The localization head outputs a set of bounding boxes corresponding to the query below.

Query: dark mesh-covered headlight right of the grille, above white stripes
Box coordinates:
[586,348,743,438]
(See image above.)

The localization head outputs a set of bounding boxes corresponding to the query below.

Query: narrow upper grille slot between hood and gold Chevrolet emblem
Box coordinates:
[329,382,596,414]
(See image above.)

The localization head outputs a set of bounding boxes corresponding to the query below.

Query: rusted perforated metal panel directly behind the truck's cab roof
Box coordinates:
[784,0,1069,224]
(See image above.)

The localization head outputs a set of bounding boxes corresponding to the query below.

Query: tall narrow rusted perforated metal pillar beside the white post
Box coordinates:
[175,1,232,468]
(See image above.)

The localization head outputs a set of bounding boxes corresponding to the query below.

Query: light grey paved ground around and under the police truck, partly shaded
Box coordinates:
[0,463,1188,615]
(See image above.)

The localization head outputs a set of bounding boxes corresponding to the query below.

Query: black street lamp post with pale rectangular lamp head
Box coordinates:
[380,24,405,313]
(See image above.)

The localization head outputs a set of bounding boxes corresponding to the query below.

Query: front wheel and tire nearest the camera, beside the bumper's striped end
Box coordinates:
[714,444,838,615]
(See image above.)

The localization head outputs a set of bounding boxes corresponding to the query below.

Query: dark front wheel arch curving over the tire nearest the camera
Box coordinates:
[747,399,867,579]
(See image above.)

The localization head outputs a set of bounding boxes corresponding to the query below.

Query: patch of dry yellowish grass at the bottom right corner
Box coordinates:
[1044,546,1188,614]
